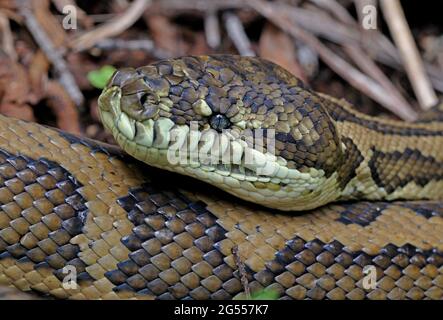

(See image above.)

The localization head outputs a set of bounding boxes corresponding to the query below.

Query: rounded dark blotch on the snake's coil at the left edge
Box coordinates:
[0,149,91,288]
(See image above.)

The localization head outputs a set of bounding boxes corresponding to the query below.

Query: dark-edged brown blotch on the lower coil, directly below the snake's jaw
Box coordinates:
[110,183,236,299]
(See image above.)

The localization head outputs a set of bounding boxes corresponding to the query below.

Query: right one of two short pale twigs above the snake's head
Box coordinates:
[223,12,255,56]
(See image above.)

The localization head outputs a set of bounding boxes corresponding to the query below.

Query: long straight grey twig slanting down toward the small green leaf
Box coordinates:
[19,0,85,106]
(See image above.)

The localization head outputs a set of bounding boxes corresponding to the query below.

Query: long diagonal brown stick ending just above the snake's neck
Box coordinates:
[251,0,417,121]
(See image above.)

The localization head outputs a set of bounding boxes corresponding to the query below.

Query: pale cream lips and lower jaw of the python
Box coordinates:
[99,86,340,211]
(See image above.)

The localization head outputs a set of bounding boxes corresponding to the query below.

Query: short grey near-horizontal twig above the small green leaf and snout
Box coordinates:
[94,39,173,59]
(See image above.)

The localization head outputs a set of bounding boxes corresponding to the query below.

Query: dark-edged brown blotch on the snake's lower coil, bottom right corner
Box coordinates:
[250,232,443,300]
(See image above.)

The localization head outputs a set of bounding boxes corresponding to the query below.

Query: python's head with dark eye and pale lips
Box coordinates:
[99,55,344,211]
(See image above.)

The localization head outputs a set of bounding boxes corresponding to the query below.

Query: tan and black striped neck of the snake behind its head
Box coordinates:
[320,94,443,200]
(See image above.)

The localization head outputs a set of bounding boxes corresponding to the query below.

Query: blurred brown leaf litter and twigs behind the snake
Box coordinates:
[0,0,443,143]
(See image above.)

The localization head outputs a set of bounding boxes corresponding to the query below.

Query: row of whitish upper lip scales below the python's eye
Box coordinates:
[102,111,314,184]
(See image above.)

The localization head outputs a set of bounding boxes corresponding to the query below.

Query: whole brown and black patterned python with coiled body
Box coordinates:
[0,55,443,300]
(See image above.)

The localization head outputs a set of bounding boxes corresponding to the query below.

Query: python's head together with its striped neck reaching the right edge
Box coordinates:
[99,55,443,211]
